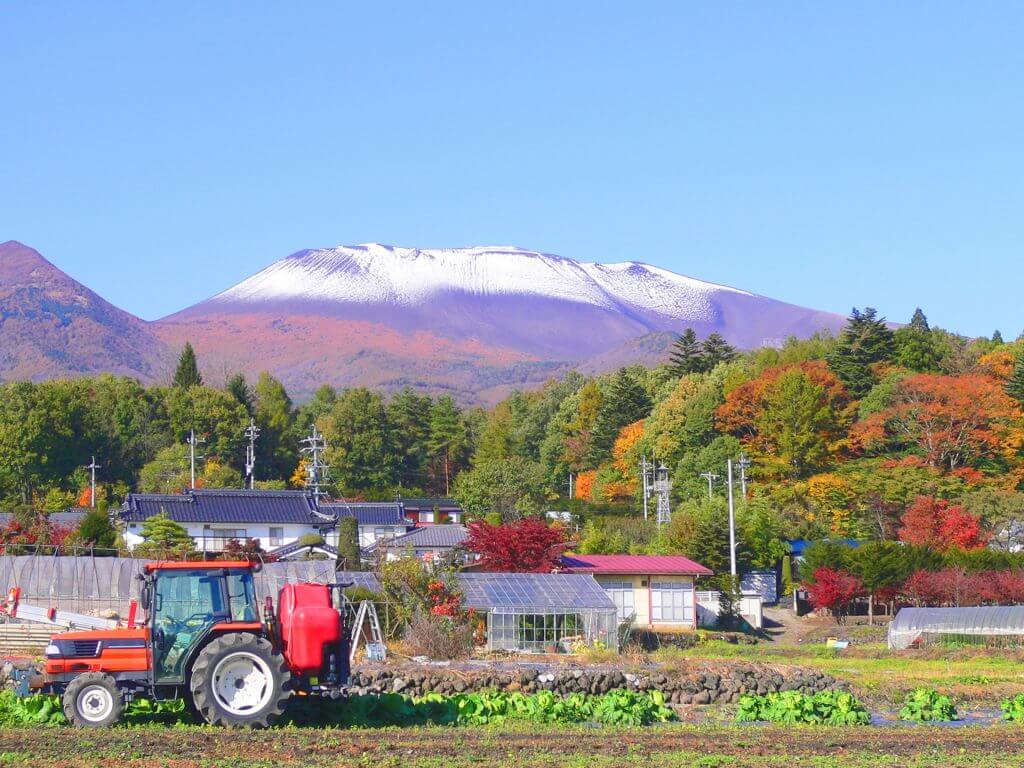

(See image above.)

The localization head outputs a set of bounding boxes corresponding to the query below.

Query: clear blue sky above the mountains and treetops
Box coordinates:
[0,0,1024,337]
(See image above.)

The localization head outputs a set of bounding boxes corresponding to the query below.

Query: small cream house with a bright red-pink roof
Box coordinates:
[562,555,712,630]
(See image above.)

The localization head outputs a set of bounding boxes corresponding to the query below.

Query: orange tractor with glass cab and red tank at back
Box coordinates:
[24,561,349,728]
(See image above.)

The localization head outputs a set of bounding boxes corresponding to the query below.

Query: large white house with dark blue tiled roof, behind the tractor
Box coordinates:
[118,488,412,557]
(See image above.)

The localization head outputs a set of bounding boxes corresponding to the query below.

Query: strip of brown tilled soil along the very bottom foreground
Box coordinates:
[0,725,1024,768]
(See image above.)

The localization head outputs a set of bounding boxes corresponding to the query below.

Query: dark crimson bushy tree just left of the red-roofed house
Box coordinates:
[466,517,566,573]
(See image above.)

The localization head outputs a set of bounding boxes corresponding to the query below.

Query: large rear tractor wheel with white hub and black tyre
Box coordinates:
[188,632,292,728]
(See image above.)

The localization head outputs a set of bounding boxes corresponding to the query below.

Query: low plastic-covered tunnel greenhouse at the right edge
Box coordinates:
[889,605,1024,650]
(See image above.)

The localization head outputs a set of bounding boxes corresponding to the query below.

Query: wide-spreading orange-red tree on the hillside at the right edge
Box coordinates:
[854,374,1020,470]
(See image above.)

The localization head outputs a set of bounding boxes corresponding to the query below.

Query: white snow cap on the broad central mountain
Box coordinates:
[211,243,749,322]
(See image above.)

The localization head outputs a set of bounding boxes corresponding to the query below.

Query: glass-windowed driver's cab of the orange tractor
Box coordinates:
[153,570,257,682]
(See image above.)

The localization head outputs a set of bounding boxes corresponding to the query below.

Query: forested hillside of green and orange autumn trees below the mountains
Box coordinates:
[0,310,1024,581]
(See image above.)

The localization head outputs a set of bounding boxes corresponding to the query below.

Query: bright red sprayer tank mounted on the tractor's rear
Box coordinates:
[278,584,341,676]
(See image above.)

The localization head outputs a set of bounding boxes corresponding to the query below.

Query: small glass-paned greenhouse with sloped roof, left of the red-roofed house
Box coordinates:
[459,573,618,653]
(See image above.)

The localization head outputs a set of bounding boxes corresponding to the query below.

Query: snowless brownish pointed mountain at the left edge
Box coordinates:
[0,241,167,381]
